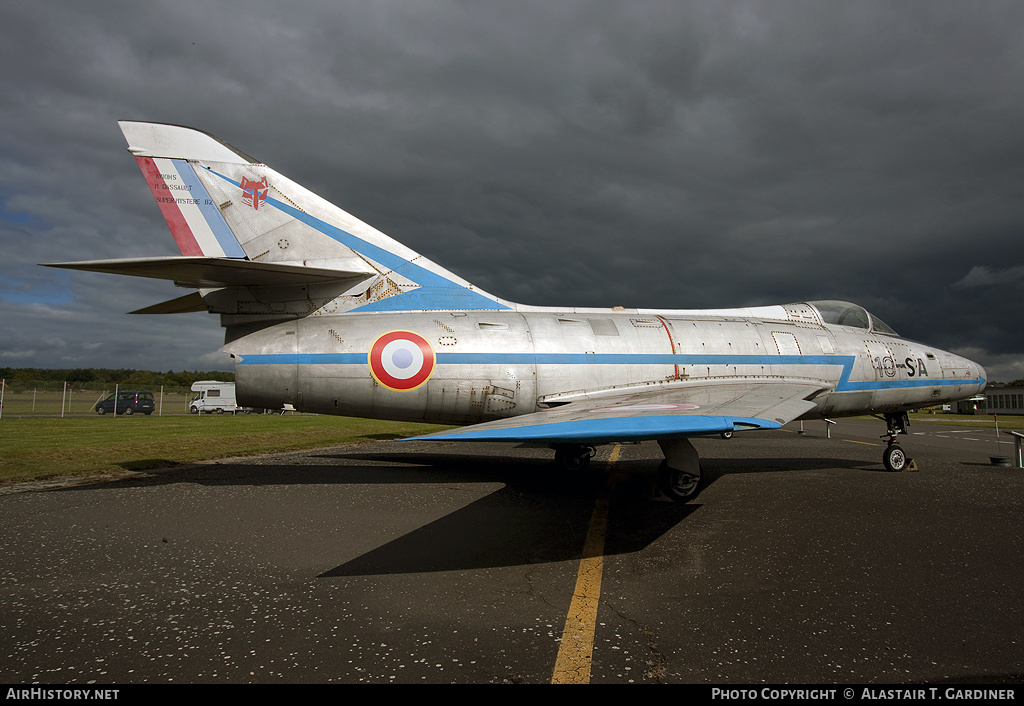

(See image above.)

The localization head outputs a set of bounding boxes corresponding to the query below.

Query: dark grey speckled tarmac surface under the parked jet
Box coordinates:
[0,421,1024,684]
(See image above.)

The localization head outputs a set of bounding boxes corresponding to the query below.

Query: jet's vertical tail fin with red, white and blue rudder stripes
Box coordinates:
[119,121,509,310]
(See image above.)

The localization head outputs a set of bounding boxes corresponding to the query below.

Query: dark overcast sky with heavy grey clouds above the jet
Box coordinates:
[0,0,1024,380]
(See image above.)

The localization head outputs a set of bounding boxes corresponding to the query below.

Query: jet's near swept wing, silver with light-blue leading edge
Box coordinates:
[407,381,824,444]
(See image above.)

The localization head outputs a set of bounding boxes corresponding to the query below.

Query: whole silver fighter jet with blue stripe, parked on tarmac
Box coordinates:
[53,121,985,501]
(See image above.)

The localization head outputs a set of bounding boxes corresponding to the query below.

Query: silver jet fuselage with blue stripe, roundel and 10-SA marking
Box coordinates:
[227,304,984,424]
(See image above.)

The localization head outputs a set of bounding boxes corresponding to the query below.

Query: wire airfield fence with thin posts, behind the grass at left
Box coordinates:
[0,380,196,419]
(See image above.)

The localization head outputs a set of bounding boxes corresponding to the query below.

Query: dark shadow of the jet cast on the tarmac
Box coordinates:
[59,447,869,578]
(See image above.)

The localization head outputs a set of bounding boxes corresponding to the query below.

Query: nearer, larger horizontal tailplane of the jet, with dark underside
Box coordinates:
[46,257,373,289]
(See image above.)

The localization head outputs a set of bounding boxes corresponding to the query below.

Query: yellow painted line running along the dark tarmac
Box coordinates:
[551,444,623,683]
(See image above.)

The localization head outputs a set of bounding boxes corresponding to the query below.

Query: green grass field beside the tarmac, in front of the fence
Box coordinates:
[0,414,445,483]
